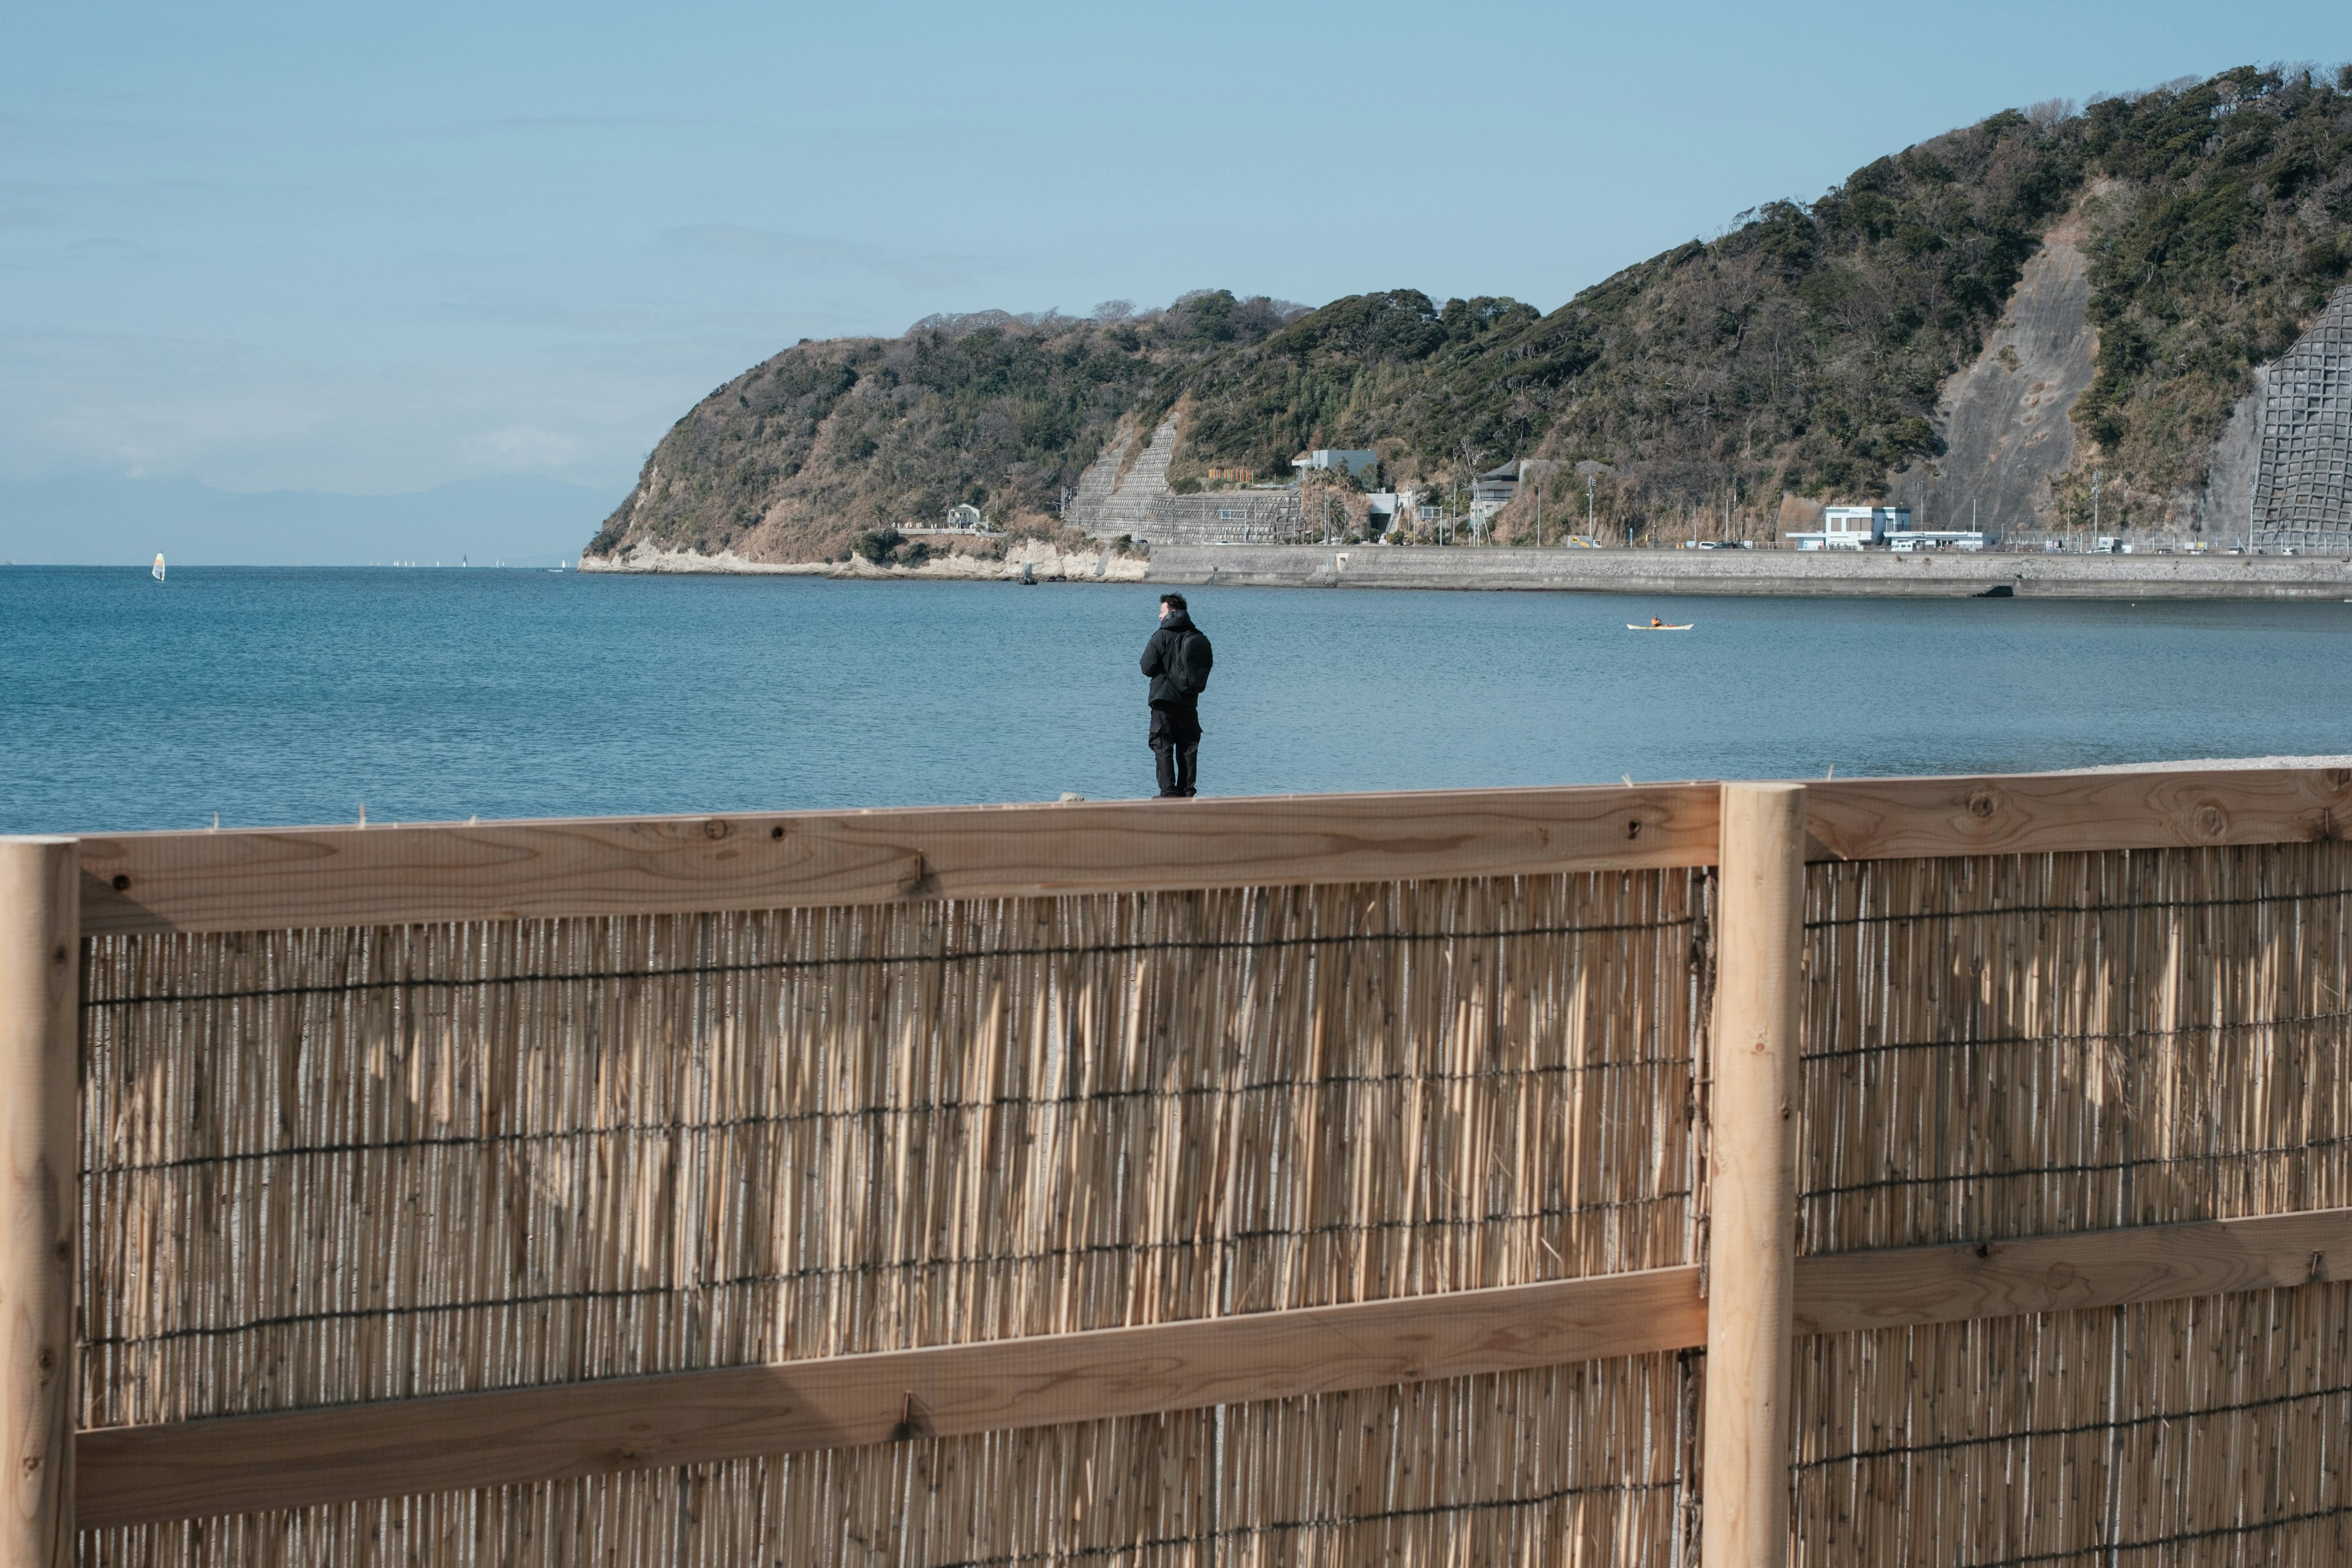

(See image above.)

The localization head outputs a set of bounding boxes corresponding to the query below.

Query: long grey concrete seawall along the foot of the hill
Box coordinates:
[1145,545,2352,600]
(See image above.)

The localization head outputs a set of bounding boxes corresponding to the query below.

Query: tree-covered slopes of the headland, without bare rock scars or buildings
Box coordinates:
[590,68,2352,559]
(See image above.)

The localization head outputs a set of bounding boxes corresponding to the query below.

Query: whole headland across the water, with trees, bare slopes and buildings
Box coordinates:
[581,66,2352,576]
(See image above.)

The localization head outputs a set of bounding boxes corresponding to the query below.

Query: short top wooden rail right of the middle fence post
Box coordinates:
[1806,769,2352,861]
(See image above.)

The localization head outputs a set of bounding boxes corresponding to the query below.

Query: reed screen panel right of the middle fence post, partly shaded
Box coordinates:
[1795,842,2352,1568]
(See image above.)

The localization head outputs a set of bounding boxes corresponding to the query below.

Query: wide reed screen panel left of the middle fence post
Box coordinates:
[82,872,1710,1568]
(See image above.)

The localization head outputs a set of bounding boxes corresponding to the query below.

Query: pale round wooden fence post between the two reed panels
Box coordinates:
[1700,785,1804,1568]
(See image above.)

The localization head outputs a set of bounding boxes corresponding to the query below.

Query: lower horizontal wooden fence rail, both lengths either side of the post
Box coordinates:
[75,1208,2352,1528]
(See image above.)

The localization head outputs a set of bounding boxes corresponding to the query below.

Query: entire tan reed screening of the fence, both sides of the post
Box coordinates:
[64,844,2352,1568]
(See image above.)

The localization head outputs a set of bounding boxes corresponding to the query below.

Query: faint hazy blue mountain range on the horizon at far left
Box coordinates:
[0,475,614,567]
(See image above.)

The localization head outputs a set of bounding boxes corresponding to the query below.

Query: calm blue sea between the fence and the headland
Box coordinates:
[0,569,2352,832]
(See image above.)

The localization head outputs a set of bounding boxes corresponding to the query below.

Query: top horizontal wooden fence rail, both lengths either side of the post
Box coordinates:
[82,769,2352,933]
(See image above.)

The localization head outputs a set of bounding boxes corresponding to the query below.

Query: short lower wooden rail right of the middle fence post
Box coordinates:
[1797,1208,2352,1333]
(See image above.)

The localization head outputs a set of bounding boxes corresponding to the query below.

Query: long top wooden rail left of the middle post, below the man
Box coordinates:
[82,785,1717,933]
